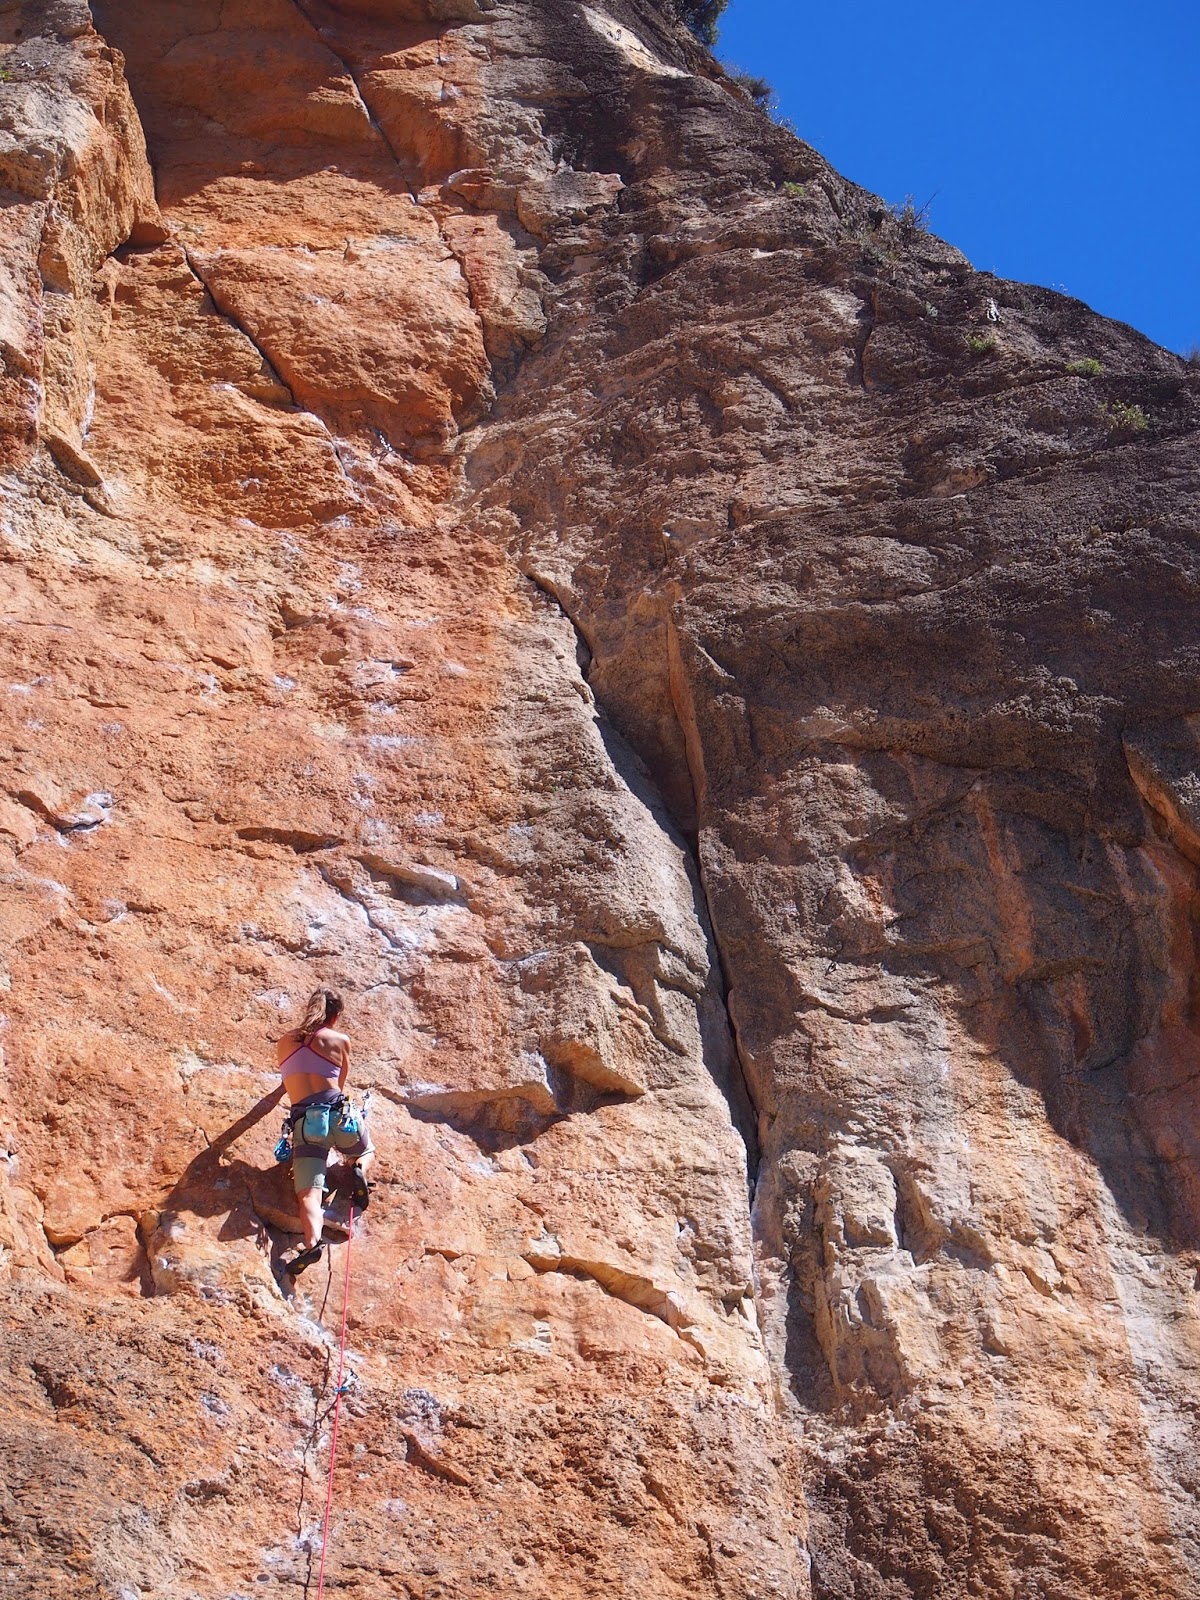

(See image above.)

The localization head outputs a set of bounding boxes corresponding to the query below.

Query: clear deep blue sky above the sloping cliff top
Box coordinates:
[717,0,1200,350]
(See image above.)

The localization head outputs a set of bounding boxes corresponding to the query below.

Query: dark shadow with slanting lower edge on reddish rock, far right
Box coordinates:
[934,755,1200,1250]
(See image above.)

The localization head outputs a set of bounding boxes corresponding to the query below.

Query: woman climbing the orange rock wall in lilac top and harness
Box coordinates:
[275,989,374,1277]
